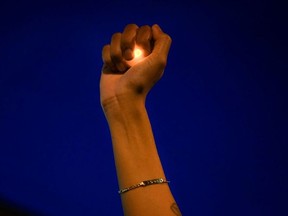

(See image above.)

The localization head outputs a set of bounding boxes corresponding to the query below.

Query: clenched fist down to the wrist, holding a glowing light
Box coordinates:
[100,24,171,110]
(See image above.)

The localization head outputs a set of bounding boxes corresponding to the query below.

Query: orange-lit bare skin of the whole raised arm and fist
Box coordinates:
[100,24,181,216]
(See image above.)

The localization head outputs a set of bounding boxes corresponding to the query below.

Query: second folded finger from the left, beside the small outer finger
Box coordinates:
[110,33,126,72]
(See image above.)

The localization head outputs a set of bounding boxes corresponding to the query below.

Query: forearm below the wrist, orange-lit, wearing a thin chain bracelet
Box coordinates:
[105,98,180,215]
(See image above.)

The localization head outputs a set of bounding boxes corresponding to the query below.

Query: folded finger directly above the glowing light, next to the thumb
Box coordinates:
[136,25,152,56]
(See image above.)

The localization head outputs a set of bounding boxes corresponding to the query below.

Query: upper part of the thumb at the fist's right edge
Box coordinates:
[152,24,172,63]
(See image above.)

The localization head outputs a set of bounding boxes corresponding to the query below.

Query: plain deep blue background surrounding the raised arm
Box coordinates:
[0,0,288,216]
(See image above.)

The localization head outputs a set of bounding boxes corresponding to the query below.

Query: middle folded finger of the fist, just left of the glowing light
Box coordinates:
[121,24,139,60]
